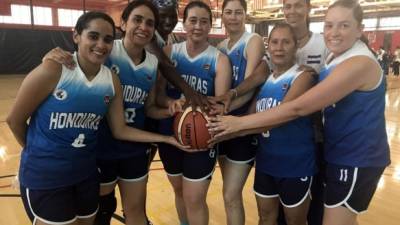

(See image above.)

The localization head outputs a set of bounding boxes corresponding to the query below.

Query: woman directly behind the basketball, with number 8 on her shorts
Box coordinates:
[158,1,231,225]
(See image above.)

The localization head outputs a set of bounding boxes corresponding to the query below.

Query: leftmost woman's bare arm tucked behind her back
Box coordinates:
[7,60,62,147]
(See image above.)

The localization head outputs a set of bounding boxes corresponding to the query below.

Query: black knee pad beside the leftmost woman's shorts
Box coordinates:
[94,191,117,225]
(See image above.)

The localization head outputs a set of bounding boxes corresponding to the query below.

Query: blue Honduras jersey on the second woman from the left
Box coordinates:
[97,40,158,159]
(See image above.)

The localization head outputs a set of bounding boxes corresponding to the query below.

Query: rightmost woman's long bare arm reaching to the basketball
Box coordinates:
[209,56,382,136]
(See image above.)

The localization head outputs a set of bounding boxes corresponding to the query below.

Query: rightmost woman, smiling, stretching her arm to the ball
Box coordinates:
[210,0,390,225]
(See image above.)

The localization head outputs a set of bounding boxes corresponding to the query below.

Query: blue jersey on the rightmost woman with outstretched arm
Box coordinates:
[320,41,390,167]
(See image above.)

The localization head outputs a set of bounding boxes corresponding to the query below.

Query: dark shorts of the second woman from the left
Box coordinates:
[97,149,151,185]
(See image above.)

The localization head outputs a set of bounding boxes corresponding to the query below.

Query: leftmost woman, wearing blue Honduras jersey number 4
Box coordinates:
[7,12,186,224]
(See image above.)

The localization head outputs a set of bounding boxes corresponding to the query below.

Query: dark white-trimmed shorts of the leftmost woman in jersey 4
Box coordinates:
[20,174,99,224]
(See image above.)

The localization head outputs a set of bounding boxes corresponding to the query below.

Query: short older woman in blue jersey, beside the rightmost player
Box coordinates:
[253,24,316,225]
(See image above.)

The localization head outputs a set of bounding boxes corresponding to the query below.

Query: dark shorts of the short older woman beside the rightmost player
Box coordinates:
[254,170,313,208]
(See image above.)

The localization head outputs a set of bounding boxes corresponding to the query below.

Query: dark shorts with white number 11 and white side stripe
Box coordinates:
[324,164,385,214]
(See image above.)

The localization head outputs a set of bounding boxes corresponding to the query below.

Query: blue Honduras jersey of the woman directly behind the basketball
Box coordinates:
[160,42,220,135]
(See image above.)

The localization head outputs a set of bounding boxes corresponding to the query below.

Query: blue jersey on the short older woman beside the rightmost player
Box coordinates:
[256,64,316,177]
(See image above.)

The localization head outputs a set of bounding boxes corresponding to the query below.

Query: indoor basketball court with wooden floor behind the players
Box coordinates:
[0,0,400,225]
